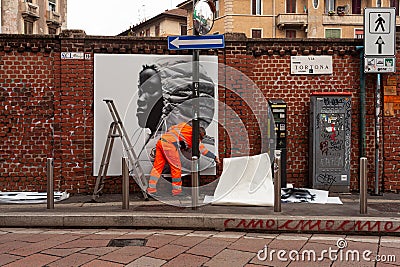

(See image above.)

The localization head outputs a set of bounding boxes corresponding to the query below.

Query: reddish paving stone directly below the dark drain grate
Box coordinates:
[99,246,154,264]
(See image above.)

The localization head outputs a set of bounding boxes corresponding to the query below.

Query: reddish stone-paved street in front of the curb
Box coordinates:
[0,228,400,267]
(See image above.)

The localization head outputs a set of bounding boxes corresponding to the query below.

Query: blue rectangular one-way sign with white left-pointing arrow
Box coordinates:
[168,34,225,50]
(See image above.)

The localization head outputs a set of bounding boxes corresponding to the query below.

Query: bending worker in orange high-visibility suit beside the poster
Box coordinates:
[147,123,220,196]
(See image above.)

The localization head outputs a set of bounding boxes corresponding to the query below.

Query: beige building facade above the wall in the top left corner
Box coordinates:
[0,0,67,34]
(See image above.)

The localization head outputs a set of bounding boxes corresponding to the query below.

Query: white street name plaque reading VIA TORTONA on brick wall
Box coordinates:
[290,56,333,74]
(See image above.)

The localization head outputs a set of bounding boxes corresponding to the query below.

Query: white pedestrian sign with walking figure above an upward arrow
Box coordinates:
[364,7,396,56]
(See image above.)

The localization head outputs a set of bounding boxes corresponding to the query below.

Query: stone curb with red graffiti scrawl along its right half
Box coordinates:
[0,212,400,236]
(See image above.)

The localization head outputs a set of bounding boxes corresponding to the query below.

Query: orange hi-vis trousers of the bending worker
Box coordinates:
[147,139,182,195]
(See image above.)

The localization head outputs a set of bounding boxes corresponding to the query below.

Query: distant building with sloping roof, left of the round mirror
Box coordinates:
[119,8,188,37]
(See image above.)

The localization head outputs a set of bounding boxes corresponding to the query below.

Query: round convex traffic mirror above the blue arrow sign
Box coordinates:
[193,0,215,35]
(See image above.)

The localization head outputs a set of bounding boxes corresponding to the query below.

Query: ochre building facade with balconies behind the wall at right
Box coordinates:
[178,0,400,39]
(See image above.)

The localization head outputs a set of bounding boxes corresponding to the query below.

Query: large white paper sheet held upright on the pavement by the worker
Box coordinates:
[211,154,274,206]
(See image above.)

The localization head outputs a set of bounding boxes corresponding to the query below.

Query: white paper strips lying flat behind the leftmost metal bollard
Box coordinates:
[0,192,69,204]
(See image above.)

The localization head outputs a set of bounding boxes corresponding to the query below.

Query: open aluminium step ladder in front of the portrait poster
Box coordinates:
[92,99,148,201]
